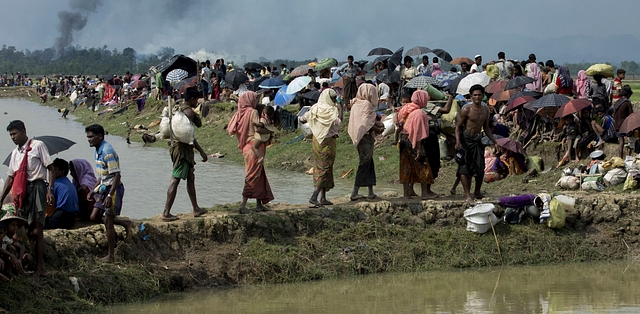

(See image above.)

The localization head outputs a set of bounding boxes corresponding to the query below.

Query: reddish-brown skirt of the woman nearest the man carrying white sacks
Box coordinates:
[242,143,273,204]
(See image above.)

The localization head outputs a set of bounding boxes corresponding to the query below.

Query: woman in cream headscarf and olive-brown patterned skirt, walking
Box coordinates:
[300,89,342,208]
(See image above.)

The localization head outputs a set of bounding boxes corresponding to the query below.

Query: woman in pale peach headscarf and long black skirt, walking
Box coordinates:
[348,83,384,201]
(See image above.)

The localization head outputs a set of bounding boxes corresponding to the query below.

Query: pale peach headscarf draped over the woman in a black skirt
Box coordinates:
[347,83,378,146]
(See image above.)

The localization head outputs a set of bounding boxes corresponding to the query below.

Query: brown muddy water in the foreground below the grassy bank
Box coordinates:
[110,262,640,314]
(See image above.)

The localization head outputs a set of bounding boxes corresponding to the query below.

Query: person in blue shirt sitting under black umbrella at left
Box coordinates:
[44,158,79,229]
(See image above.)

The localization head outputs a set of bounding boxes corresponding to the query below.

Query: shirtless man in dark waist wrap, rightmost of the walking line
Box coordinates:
[456,84,496,202]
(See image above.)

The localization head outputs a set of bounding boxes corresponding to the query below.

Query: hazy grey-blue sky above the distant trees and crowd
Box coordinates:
[0,0,640,62]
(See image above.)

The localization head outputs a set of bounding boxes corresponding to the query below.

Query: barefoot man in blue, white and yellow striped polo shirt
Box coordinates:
[84,124,133,263]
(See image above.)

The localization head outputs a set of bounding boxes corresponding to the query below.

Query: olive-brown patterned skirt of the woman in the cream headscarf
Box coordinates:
[311,136,336,191]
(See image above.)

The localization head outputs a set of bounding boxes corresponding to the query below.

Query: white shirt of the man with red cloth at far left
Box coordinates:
[7,140,53,182]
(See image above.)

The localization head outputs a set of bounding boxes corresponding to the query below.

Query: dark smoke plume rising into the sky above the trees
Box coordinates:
[54,0,102,55]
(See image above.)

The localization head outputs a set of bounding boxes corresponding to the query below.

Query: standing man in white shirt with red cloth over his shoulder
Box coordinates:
[0,120,55,279]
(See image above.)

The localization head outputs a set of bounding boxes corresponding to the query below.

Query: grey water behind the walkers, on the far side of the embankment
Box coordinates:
[0,99,388,218]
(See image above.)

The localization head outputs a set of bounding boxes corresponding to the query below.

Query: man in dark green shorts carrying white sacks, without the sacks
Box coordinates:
[162,87,207,221]
